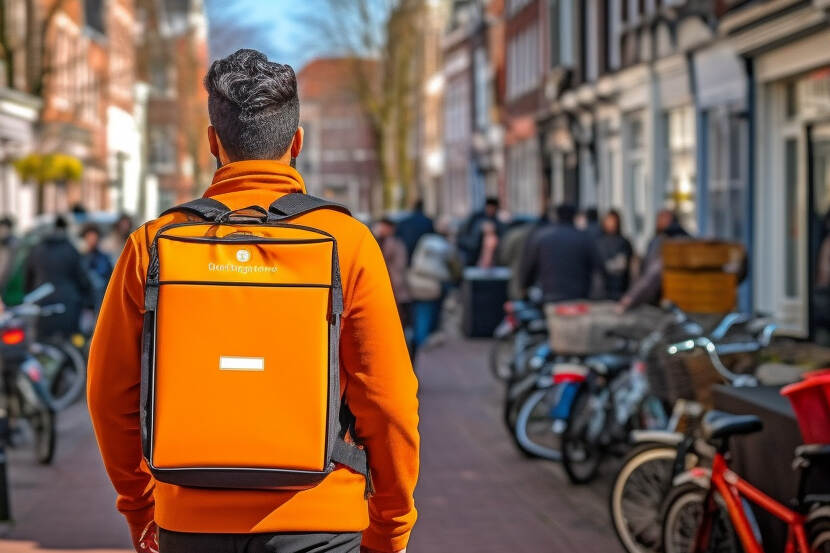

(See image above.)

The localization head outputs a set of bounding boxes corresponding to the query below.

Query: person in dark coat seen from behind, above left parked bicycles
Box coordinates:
[25,216,93,337]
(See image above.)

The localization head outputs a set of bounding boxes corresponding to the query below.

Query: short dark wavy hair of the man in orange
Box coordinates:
[205,49,300,161]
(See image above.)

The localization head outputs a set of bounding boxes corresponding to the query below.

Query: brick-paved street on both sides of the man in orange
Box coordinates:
[0,341,619,553]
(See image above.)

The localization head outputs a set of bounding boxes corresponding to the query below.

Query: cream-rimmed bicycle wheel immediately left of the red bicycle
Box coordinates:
[609,443,677,553]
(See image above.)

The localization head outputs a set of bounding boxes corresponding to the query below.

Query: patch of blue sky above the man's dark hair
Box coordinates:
[205,0,328,71]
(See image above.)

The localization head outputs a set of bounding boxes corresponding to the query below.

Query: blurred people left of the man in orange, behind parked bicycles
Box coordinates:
[0,207,133,337]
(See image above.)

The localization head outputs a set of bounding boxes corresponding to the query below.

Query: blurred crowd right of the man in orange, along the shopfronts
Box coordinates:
[373,198,700,352]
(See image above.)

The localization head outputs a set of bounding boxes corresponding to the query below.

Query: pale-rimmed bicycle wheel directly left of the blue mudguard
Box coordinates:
[513,386,562,461]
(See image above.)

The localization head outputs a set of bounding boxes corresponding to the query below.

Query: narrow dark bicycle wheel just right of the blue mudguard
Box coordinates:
[562,386,606,484]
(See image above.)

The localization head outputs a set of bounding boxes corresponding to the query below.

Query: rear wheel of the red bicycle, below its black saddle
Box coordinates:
[663,484,743,553]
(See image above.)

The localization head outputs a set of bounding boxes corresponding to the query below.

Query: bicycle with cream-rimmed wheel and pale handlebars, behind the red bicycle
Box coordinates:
[609,313,776,553]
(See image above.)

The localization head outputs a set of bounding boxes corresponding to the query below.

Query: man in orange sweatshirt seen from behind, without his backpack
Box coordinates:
[88,50,419,553]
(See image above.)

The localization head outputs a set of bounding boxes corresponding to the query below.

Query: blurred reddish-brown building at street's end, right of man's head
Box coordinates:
[297,58,382,218]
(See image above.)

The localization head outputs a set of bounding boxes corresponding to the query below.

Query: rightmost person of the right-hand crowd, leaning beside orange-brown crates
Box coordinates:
[620,209,690,311]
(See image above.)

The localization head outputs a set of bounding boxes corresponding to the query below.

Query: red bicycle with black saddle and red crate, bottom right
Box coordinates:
[663,372,830,553]
